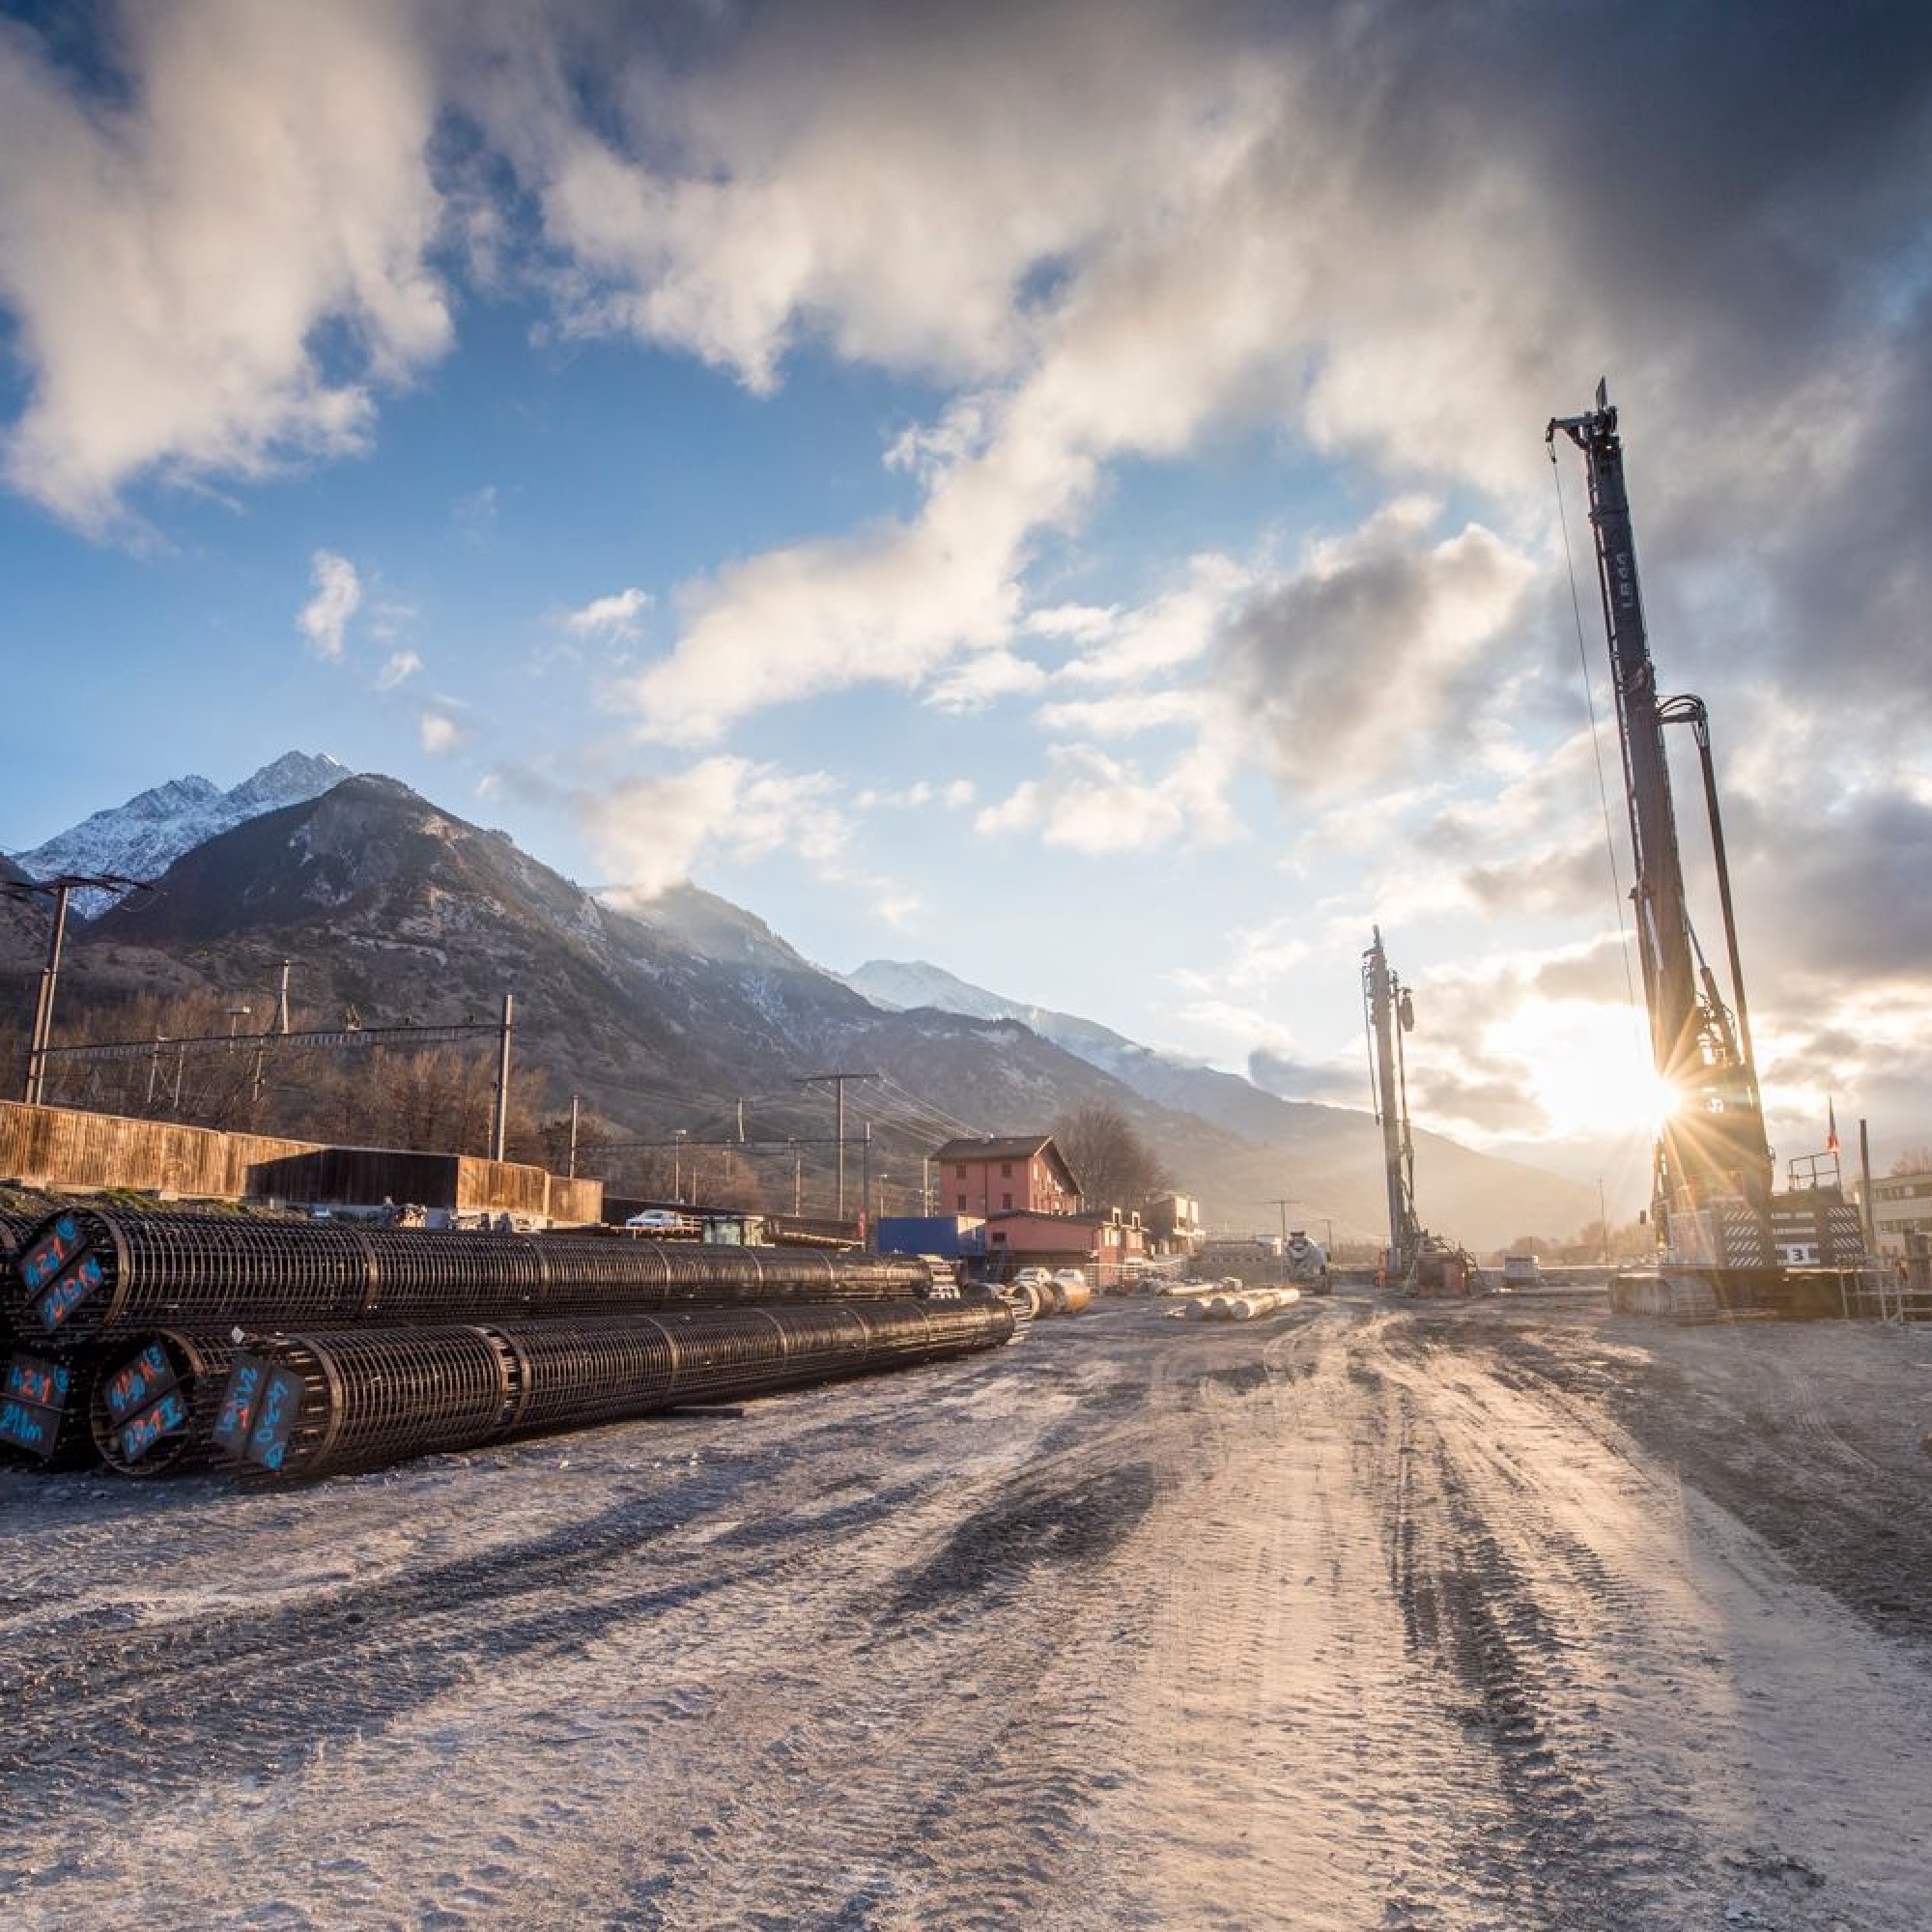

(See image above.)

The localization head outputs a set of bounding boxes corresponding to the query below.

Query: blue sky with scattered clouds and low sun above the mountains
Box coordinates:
[0,0,1932,1211]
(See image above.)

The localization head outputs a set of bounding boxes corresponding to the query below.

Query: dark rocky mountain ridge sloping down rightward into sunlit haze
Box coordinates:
[10,775,1594,1246]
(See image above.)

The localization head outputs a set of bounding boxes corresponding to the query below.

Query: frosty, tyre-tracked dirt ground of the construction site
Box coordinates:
[0,1293,1932,1932]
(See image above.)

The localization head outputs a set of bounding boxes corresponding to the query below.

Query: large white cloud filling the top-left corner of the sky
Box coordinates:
[0,0,450,529]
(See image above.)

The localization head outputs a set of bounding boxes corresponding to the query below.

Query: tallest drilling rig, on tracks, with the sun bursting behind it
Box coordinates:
[1544,383,1864,1314]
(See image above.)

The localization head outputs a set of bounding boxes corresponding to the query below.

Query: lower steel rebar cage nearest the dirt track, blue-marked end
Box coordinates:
[213,1300,1012,1476]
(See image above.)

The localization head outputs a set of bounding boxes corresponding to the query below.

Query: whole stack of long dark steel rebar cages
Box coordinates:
[0,1208,1012,1476]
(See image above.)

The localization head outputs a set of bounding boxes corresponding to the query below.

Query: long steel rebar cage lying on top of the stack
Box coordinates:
[4,1208,931,1345]
